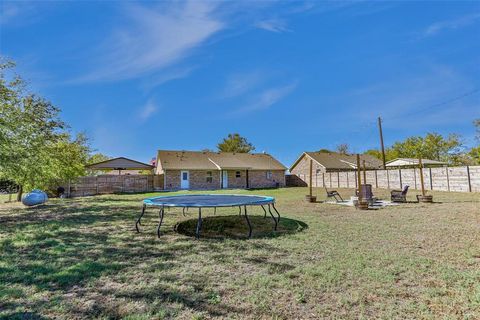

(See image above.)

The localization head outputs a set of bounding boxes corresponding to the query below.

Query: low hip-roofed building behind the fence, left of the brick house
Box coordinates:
[86,157,155,175]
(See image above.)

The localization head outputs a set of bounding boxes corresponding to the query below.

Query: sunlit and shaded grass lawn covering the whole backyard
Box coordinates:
[0,188,480,319]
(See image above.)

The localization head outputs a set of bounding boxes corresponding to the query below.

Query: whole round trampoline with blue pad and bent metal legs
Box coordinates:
[135,194,280,239]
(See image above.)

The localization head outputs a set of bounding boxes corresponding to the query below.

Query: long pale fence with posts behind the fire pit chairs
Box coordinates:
[286,166,480,192]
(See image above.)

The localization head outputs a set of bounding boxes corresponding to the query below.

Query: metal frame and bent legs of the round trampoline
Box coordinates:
[135,194,280,239]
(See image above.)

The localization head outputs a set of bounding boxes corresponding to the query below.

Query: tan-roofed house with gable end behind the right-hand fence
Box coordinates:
[290,152,382,180]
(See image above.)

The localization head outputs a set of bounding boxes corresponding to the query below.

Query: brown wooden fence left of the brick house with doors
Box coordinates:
[64,175,163,197]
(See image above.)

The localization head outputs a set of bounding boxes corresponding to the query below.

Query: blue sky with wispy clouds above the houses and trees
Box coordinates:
[0,1,480,166]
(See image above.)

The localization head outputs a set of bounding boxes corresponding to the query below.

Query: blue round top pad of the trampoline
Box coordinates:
[143,194,275,208]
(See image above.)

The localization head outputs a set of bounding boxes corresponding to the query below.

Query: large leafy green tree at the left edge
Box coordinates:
[0,62,90,198]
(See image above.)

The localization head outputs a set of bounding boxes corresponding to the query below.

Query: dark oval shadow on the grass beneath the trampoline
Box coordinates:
[176,215,308,240]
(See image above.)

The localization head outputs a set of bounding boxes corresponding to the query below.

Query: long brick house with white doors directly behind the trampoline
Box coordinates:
[155,150,287,190]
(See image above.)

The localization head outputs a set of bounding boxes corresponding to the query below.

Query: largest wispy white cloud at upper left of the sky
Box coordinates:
[74,1,224,82]
